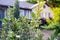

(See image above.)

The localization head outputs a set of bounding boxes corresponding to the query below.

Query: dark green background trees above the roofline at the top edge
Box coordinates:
[27,0,60,7]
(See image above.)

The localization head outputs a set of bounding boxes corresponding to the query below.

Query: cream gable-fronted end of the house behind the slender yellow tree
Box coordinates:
[32,3,53,19]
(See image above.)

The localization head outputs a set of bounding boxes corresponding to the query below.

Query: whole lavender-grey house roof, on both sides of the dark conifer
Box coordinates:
[0,0,34,9]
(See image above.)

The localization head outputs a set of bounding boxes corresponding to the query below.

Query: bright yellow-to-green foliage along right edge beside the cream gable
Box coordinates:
[43,7,60,40]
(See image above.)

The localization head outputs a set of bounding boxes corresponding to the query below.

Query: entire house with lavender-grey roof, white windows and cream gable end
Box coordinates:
[0,0,52,24]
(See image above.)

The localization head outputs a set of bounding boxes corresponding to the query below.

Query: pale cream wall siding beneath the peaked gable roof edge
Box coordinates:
[32,4,53,19]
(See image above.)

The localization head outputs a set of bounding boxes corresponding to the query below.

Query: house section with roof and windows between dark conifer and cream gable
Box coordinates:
[20,1,34,19]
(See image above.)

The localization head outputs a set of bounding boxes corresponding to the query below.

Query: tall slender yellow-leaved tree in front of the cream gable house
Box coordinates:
[31,0,45,28]
